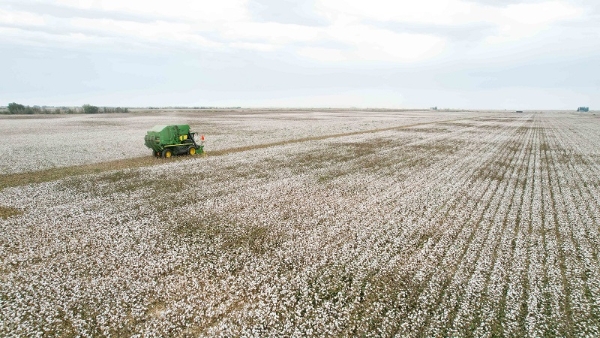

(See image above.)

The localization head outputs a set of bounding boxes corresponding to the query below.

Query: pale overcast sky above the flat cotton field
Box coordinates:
[0,0,600,109]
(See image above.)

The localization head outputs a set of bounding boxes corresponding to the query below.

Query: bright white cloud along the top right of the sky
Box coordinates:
[317,0,584,42]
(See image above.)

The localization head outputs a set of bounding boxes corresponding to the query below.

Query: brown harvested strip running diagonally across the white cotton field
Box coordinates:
[0,116,483,191]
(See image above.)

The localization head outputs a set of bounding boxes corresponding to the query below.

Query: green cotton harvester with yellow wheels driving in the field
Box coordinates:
[144,124,204,158]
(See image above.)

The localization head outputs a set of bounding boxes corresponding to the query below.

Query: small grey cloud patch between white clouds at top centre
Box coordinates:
[248,0,327,26]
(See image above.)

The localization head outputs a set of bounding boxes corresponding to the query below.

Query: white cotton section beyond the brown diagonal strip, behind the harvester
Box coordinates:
[0,111,480,174]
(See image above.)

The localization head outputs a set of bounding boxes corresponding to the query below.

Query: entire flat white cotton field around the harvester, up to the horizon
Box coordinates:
[0,110,600,337]
